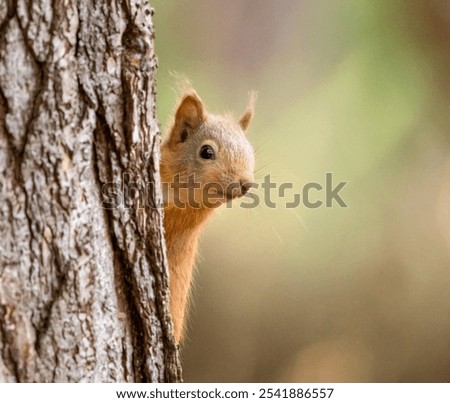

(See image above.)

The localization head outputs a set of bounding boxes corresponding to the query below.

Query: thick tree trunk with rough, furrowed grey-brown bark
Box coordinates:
[0,0,181,382]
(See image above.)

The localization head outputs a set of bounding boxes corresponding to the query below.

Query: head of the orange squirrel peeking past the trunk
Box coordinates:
[161,90,256,207]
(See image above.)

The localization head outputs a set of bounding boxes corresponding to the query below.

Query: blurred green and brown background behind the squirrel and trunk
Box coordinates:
[151,0,450,382]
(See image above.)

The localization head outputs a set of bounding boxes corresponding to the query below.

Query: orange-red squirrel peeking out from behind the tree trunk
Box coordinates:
[160,88,256,343]
